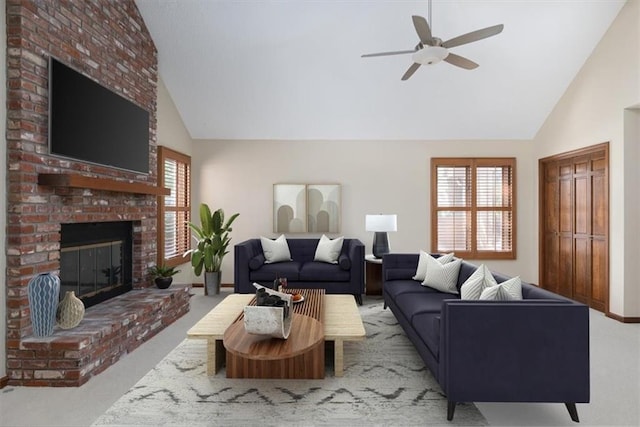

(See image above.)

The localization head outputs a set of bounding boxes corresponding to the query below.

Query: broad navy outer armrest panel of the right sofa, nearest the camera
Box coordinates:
[438,300,589,403]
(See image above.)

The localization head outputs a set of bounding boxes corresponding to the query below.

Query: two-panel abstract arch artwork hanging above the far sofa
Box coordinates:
[273,184,341,233]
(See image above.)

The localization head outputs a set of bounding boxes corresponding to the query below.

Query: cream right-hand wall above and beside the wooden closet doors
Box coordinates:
[532,0,640,317]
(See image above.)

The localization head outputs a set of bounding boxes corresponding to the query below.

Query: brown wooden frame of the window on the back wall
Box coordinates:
[430,157,517,260]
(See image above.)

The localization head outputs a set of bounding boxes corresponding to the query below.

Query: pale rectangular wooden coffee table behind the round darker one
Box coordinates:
[187,294,366,377]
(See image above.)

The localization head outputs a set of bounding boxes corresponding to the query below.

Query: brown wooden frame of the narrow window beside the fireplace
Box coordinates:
[156,146,191,267]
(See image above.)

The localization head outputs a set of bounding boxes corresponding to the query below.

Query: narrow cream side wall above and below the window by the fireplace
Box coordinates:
[157,78,193,283]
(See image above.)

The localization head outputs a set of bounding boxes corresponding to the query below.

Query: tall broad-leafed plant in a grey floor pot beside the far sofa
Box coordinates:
[185,203,240,295]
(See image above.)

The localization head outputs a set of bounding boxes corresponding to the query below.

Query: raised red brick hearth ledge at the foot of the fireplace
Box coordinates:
[8,285,190,387]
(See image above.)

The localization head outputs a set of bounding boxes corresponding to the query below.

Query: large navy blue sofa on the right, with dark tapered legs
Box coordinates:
[382,254,590,422]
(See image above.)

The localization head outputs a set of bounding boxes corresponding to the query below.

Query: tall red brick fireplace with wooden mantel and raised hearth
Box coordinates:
[6,0,188,386]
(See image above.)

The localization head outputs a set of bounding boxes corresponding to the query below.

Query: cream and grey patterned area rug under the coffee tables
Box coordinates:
[93,299,487,426]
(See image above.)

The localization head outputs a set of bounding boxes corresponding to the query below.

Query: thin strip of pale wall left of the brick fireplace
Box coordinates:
[0,0,7,378]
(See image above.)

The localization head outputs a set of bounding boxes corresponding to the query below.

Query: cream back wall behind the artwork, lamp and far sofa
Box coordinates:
[192,140,537,283]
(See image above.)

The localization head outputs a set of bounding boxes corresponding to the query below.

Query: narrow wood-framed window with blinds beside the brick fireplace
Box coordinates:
[158,147,191,266]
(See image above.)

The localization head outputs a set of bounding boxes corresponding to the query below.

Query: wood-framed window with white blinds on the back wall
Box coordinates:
[431,158,516,259]
